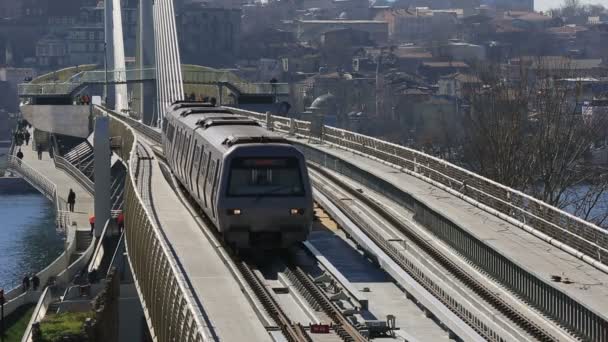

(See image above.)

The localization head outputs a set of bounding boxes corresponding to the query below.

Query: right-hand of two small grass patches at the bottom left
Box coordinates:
[40,311,93,342]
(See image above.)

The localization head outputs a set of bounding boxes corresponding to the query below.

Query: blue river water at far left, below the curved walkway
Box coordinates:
[0,184,64,289]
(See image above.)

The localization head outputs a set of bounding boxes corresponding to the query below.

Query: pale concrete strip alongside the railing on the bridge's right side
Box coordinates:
[295,139,608,319]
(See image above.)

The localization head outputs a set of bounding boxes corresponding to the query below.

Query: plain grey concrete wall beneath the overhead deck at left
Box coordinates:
[21,105,90,138]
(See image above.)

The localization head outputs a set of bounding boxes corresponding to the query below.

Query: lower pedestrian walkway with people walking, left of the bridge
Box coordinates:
[15,131,94,231]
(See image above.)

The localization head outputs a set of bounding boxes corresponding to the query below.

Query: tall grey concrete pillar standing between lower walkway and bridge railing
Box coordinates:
[93,116,112,237]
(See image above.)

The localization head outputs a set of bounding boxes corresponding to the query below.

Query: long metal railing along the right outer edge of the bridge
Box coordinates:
[227,108,608,269]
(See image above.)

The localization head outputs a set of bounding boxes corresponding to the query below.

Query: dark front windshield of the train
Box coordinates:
[228,158,304,197]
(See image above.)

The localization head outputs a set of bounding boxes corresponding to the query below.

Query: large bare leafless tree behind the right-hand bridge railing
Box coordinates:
[464,57,608,223]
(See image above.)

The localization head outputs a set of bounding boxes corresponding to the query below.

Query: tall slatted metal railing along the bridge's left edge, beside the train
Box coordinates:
[101,107,208,342]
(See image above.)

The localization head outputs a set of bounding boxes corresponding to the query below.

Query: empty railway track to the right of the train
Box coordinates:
[309,163,559,341]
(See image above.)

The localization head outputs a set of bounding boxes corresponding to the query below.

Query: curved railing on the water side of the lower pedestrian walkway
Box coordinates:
[8,155,70,230]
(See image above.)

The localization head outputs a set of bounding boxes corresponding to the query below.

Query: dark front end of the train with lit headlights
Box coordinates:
[218,144,313,249]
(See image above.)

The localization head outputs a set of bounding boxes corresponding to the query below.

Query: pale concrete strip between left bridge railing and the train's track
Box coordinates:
[145,153,272,341]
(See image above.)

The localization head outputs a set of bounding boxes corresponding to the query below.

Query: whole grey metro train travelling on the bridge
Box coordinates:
[163,101,313,249]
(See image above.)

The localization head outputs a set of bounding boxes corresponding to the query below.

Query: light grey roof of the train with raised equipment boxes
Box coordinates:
[166,103,290,152]
